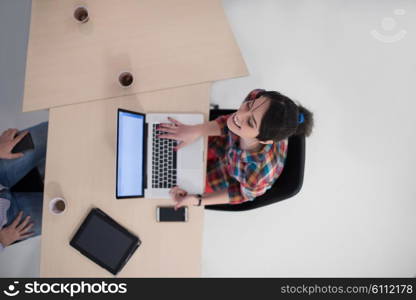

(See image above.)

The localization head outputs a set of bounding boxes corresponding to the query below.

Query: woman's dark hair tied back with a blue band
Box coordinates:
[245,90,313,141]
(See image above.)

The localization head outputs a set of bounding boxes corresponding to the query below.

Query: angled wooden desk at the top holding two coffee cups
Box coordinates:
[23,0,248,111]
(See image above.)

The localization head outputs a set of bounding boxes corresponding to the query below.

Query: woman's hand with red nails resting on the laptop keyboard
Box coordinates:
[158,117,202,150]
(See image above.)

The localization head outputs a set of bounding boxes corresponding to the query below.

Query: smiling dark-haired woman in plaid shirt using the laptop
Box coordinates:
[159,89,313,208]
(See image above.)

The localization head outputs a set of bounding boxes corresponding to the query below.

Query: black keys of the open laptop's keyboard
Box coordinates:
[152,124,178,189]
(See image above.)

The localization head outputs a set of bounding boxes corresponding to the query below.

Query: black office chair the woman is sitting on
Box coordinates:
[205,107,305,211]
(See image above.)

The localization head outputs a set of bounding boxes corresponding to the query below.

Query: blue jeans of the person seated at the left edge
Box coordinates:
[0,122,48,236]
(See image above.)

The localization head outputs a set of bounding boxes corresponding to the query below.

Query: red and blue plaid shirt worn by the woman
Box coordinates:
[207,91,288,204]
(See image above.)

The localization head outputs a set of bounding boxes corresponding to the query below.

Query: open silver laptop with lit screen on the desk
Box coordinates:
[116,109,204,199]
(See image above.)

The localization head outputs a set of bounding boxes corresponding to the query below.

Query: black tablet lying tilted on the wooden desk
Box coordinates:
[71,209,138,274]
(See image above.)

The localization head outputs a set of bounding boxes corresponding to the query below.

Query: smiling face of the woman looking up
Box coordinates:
[227,96,270,139]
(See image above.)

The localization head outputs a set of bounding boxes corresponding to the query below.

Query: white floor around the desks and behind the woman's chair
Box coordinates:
[0,0,416,277]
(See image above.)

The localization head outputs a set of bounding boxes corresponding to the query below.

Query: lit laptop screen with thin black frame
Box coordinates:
[116,109,145,198]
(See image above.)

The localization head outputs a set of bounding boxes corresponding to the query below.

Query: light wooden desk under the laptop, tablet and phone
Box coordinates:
[41,83,211,277]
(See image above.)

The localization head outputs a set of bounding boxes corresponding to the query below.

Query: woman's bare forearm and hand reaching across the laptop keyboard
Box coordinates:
[158,118,225,150]
